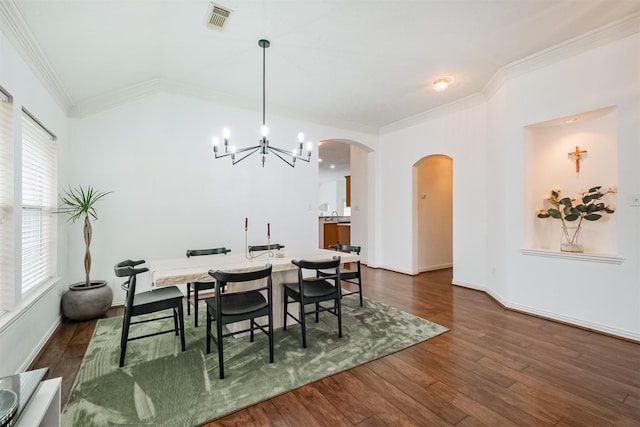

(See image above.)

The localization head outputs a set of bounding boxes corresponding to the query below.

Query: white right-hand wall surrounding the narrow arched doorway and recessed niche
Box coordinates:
[374,33,640,340]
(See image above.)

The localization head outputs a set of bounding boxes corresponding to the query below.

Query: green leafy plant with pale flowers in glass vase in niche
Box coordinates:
[538,186,617,252]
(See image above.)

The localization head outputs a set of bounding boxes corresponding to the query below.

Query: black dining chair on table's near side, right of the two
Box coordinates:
[283,256,342,348]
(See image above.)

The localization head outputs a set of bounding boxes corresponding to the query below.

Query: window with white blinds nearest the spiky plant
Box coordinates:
[22,110,57,293]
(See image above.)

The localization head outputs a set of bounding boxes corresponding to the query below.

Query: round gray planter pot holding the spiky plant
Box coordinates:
[62,280,113,320]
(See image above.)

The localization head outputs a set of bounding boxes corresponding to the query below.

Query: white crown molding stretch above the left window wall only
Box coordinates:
[0,0,73,112]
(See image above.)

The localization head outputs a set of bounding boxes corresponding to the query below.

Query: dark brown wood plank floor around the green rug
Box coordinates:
[31,267,640,427]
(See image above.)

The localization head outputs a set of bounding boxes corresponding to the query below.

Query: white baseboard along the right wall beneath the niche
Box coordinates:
[451,280,640,343]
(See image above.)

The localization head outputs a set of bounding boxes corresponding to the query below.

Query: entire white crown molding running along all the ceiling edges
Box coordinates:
[0,0,640,134]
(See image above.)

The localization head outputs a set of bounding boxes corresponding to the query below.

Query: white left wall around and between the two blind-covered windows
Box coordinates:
[0,32,67,376]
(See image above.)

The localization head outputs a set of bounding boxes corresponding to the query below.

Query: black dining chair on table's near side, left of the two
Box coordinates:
[205,264,273,379]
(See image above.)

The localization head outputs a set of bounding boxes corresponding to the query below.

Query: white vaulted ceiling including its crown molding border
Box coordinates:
[5,0,640,132]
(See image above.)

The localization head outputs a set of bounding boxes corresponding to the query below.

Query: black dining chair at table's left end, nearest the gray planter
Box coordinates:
[113,259,185,368]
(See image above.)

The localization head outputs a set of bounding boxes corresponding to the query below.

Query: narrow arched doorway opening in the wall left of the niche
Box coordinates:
[414,154,453,272]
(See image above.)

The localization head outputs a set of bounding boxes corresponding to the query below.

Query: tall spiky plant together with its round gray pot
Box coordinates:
[58,186,113,320]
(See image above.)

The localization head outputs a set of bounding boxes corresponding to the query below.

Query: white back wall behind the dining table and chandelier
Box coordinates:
[67,93,378,302]
